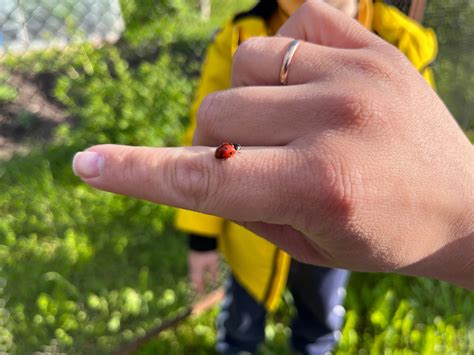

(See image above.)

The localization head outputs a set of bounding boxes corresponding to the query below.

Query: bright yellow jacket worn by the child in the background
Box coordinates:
[176,1,437,311]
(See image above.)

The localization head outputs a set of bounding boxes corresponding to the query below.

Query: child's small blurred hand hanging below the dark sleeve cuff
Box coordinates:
[188,250,219,295]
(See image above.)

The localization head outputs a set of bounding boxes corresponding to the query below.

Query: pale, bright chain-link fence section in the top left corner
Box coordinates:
[0,0,124,53]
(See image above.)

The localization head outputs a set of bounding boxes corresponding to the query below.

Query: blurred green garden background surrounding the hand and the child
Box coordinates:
[0,0,474,354]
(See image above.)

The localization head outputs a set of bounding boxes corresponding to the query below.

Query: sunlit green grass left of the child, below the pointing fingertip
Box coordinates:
[0,151,193,354]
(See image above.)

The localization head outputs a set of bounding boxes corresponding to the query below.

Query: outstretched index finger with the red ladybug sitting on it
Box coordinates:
[73,145,298,223]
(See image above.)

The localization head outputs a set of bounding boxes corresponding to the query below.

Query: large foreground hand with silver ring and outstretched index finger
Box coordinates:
[74,2,474,289]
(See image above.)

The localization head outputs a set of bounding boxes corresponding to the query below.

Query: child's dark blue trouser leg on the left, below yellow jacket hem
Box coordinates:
[216,275,267,355]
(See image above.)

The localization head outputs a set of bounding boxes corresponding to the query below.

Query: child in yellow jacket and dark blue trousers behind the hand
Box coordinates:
[176,0,437,354]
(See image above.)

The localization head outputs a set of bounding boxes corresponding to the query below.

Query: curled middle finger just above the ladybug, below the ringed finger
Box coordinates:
[193,82,344,146]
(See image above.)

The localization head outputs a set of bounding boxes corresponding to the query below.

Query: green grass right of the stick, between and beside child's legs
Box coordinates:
[138,274,474,355]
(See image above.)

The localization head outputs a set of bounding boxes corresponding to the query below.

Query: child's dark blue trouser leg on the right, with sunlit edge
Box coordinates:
[288,259,349,355]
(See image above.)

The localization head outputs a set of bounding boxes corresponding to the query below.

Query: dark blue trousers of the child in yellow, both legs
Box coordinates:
[216,259,349,355]
